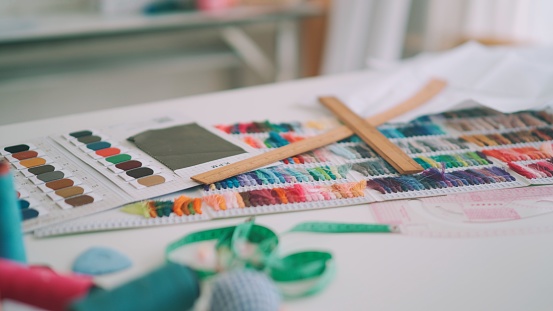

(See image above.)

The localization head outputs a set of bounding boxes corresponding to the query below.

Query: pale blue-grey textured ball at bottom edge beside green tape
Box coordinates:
[209,270,281,311]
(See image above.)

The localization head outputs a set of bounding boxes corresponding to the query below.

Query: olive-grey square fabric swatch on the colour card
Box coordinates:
[127,123,246,171]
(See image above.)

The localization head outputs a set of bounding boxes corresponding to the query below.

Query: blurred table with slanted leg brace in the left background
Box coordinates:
[0,2,321,124]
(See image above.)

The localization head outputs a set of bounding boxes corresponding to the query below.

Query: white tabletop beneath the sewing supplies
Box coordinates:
[0,73,553,311]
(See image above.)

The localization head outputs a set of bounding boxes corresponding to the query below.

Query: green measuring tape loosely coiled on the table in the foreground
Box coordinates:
[165,218,399,298]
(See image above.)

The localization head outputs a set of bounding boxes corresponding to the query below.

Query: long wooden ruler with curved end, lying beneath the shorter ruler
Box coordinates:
[191,79,446,184]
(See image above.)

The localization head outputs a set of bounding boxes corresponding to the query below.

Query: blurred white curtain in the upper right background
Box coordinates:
[323,0,553,74]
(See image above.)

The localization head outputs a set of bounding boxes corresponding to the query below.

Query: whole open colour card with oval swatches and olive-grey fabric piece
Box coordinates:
[0,116,254,232]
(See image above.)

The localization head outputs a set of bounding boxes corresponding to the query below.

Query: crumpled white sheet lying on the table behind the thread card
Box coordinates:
[337,42,553,122]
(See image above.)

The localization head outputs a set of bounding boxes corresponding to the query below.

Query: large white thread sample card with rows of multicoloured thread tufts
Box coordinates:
[33,108,553,235]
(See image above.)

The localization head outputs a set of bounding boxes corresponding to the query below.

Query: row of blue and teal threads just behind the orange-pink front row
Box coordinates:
[204,165,350,191]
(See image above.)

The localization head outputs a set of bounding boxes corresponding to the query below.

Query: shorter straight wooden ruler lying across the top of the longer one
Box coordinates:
[319,97,424,174]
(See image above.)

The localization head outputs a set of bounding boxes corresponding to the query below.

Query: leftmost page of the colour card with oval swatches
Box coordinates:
[1,137,126,232]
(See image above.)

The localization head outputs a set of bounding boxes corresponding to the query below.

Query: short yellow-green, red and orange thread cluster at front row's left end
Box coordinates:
[121,195,202,218]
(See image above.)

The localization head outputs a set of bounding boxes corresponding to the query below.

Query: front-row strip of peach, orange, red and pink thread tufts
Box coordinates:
[203,181,366,211]
